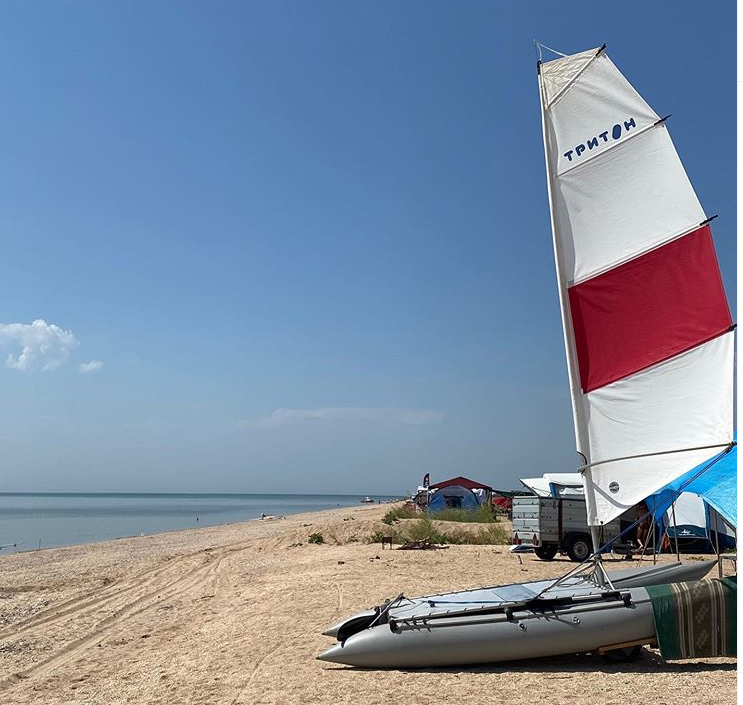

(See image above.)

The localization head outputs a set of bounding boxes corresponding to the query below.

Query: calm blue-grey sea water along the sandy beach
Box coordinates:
[0,493,390,555]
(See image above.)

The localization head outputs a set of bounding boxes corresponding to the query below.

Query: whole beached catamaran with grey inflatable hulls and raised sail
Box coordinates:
[319,47,734,668]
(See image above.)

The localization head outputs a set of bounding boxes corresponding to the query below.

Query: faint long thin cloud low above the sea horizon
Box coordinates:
[239,406,445,428]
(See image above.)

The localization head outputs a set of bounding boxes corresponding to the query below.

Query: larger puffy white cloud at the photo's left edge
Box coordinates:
[0,318,78,370]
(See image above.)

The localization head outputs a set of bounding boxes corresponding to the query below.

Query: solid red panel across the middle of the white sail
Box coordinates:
[568,225,732,393]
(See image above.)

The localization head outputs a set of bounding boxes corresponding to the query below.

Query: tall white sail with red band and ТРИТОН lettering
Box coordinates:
[539,49,734,526]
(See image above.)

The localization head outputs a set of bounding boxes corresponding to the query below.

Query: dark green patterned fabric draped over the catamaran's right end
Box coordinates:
[645,576,737,659]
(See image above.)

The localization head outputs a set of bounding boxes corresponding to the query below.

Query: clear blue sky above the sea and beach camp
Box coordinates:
[0,0,736,493]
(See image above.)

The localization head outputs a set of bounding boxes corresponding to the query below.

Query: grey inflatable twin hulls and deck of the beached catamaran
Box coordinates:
[318,561,714,668]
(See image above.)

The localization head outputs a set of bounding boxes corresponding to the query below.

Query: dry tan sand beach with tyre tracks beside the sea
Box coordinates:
[0,506,736,705]
